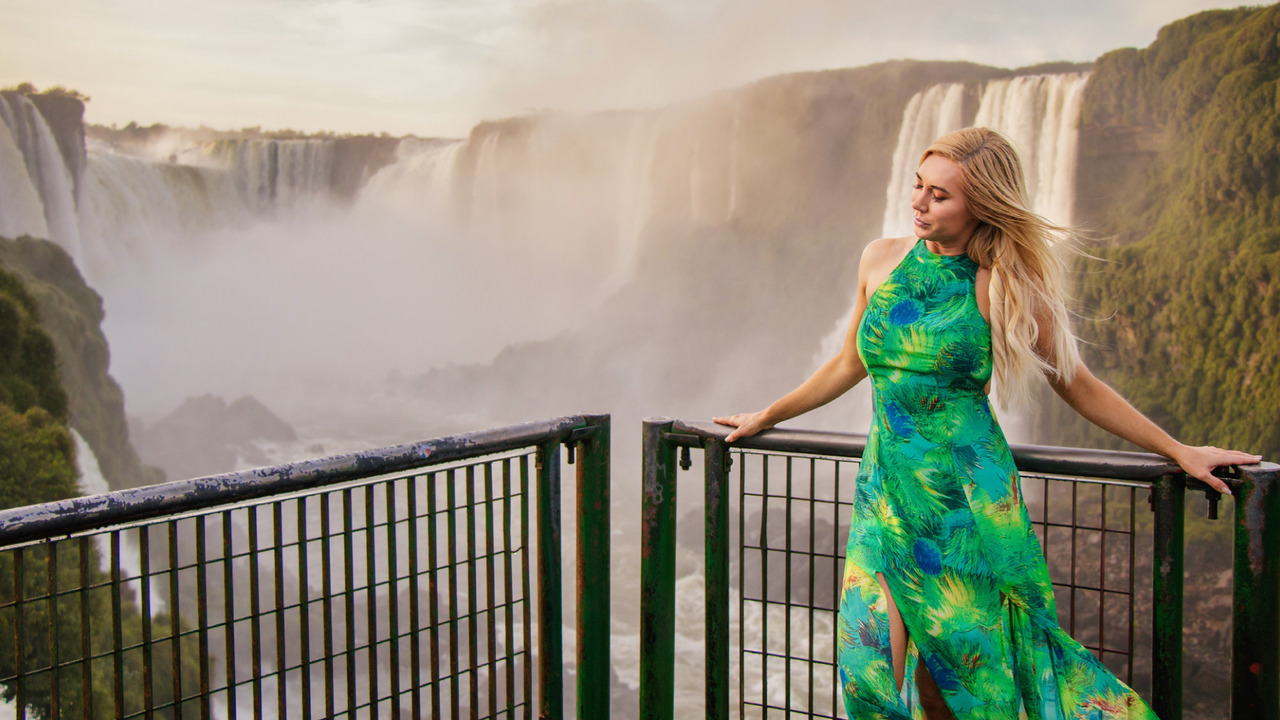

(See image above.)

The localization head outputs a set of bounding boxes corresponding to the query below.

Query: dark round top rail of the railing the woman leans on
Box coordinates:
[671,420,1280,484]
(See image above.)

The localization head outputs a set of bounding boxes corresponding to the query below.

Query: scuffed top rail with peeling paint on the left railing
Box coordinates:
[0,415,599,547]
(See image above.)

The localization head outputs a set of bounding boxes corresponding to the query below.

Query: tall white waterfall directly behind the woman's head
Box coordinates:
[814,73,1088,412]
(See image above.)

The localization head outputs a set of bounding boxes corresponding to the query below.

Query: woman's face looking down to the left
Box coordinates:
[911,155,978,255]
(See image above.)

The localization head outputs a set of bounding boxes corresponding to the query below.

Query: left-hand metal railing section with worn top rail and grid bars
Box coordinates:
[0,416,609,719]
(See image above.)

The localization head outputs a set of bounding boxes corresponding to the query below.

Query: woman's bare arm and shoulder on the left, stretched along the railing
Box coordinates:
[713,240,901,442]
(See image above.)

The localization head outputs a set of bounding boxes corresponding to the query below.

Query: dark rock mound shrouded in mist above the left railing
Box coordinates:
[132,395,298,479]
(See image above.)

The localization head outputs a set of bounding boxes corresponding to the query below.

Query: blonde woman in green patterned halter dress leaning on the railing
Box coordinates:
[716,128,1260,720]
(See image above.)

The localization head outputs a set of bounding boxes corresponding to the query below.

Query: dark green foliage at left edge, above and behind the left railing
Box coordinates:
[0,256,200,717]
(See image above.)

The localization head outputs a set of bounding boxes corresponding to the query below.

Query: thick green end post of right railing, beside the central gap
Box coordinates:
[640,419,676,720]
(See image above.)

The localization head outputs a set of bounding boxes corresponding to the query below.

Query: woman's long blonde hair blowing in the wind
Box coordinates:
[920,128,1080,407]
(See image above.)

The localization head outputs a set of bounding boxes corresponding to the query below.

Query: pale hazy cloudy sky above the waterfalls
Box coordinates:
[0,0,1259,137]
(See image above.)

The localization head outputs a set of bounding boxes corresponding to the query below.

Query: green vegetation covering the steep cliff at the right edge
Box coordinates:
[1048,5,1280,459]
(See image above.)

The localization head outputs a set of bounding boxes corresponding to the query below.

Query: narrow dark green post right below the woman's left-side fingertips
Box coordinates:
[703,439,730,720]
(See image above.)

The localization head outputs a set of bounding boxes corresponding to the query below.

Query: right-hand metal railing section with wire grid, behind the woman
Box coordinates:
[640,419,1280,720]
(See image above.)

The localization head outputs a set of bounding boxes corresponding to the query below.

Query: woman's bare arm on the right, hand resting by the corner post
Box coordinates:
[1037,322,1262,495]
